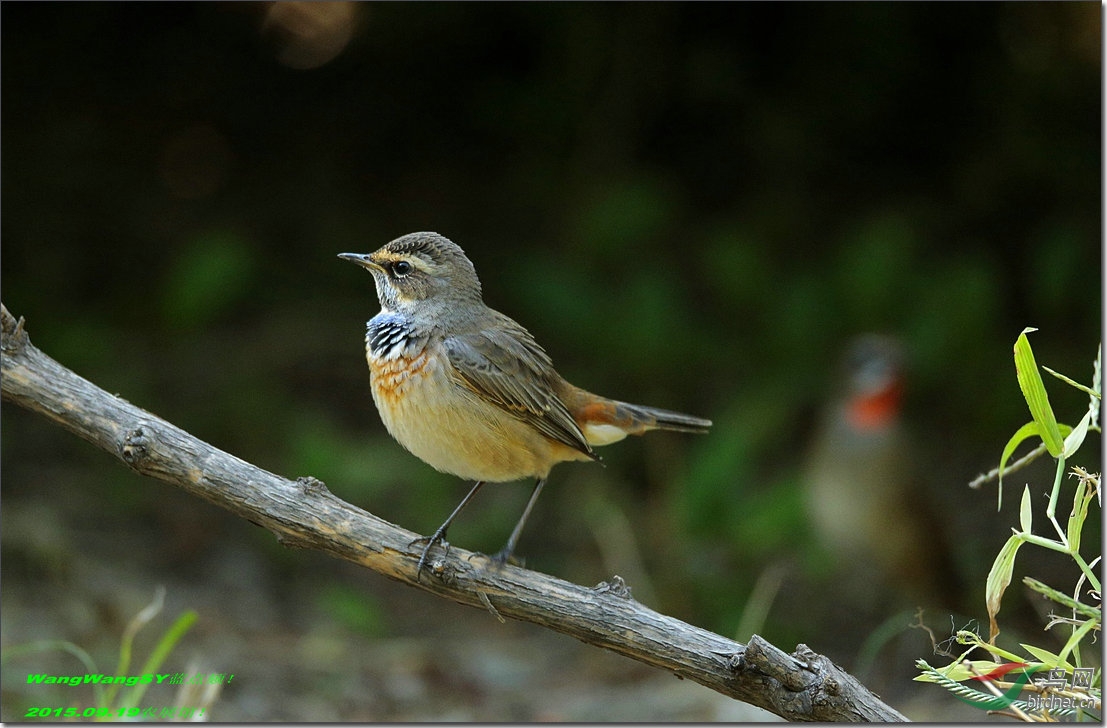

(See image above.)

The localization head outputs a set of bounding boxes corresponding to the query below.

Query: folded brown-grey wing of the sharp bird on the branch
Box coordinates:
[443,316,592,455]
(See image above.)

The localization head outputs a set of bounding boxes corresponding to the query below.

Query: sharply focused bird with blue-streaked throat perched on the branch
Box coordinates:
[339,232,712,579]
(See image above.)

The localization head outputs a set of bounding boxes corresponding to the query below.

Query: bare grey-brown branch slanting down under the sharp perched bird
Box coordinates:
[0,304,906,722]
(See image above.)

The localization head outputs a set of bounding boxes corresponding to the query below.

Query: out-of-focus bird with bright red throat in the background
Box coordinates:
[804,334,958,607]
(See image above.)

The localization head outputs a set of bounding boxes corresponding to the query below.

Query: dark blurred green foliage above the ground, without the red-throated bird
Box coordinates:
[0,2,1101,708]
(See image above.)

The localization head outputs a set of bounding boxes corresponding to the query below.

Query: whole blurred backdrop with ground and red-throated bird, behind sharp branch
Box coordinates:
[0,2,1103,721]
